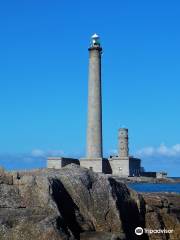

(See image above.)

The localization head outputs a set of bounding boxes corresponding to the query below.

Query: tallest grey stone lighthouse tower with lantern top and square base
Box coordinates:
[80,34,103,172]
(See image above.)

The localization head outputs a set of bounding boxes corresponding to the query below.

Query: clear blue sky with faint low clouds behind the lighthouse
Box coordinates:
[0,0,180,176]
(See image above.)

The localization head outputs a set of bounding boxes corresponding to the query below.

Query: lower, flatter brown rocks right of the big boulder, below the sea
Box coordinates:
[143,193,180,240]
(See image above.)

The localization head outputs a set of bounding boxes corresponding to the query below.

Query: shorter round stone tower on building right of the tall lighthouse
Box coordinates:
[118,128,129,158]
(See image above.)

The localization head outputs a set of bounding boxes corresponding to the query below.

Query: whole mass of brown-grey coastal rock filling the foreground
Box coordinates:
[0,164,180,240]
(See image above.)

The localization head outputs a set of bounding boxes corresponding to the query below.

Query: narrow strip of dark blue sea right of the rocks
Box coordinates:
[128,183,180,194]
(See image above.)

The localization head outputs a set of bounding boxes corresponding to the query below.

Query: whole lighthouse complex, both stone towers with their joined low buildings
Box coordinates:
[47,34,167,177]
